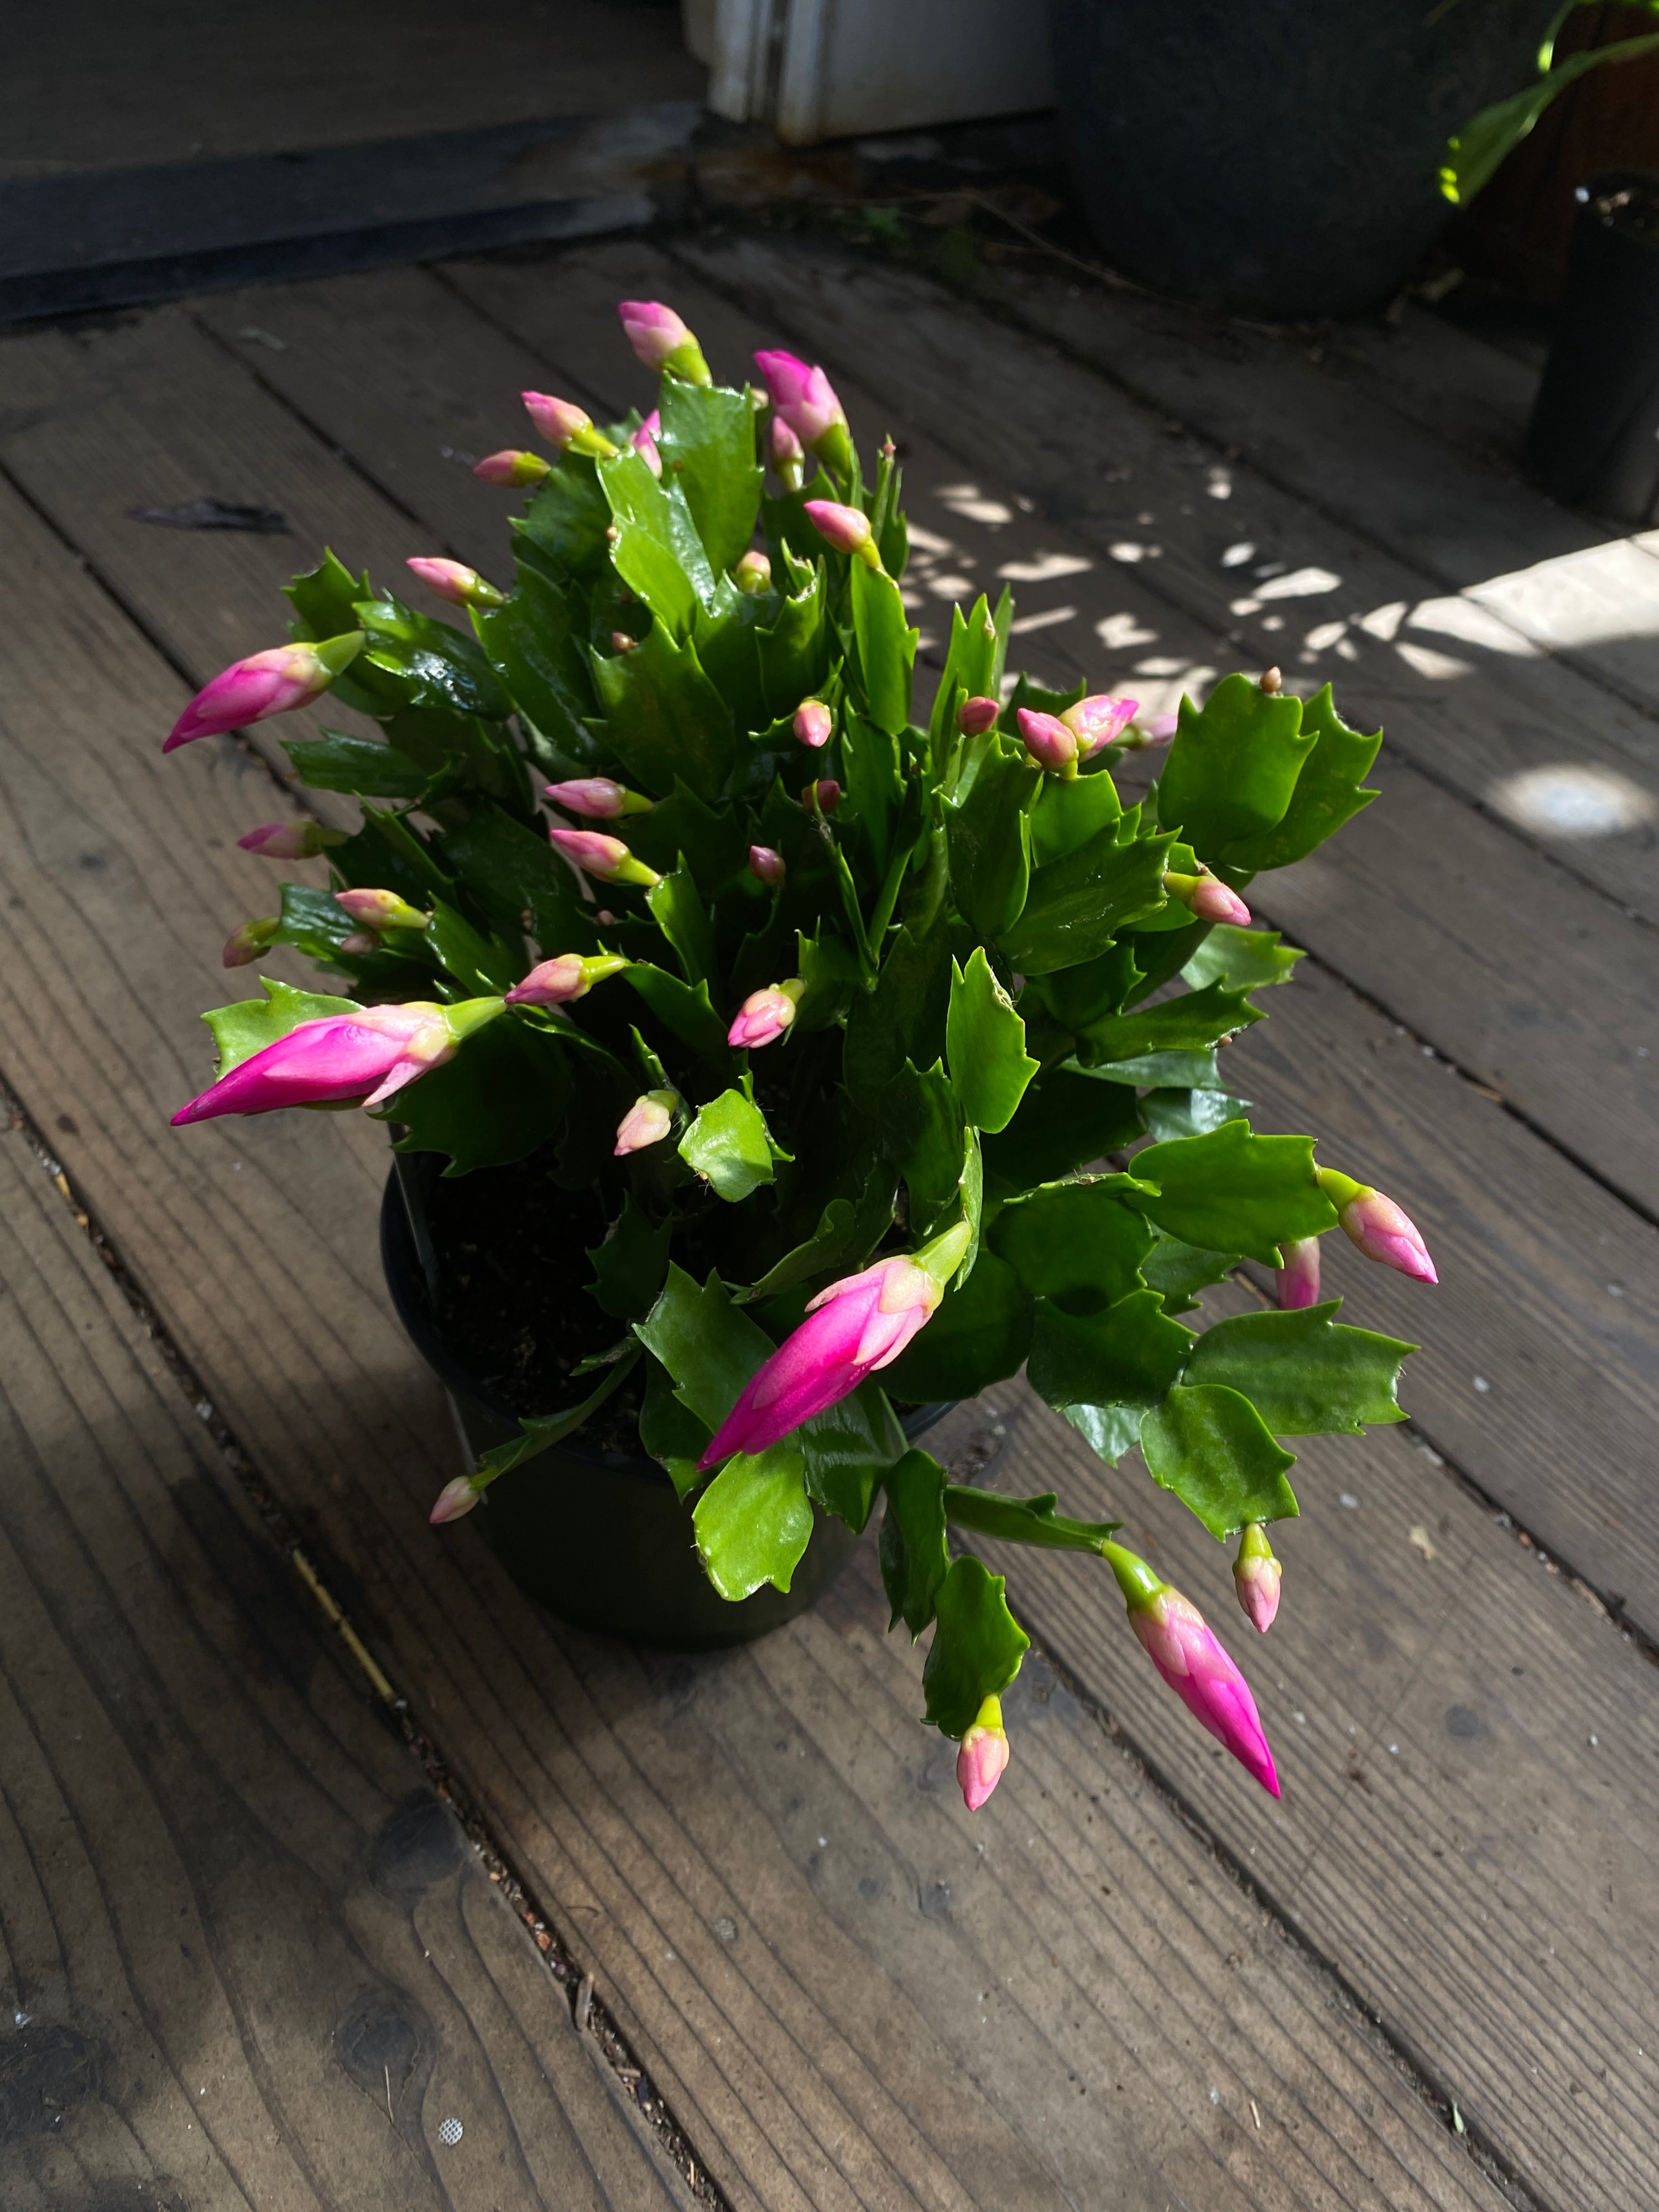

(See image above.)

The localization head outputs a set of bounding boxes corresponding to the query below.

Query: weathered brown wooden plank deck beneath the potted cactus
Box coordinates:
[0,237,1659,2212]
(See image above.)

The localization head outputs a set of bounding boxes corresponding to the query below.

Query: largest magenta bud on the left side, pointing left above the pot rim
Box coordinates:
[173,1000,471,1128]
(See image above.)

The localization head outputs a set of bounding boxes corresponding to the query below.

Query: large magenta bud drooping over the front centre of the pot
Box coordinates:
[697,1223,971,1469]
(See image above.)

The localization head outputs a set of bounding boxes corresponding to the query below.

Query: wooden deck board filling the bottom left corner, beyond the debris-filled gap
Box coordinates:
[0,1130,686,2212]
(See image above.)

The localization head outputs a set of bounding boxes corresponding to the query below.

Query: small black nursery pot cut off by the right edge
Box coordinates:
[1526,170,1659,522]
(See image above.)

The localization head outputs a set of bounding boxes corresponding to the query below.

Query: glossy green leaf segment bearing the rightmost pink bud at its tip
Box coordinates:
[1130,1121,1336,1267]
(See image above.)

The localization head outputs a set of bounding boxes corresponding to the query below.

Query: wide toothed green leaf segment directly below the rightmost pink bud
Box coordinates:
[1186,1298,1416,1436]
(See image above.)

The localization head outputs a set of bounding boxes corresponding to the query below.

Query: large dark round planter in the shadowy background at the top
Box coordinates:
[1053,0,1555,321]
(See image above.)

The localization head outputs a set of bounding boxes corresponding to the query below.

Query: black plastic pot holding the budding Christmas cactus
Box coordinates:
[380,1155,949,1652]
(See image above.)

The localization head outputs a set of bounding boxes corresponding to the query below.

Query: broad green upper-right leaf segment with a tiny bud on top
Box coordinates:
[1157,677,1314,860]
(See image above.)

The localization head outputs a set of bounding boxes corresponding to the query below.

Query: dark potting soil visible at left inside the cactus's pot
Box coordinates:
[427,1148,644,1453]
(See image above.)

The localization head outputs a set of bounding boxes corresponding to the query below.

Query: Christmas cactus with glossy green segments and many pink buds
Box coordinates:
[168,303,1433,1807]
